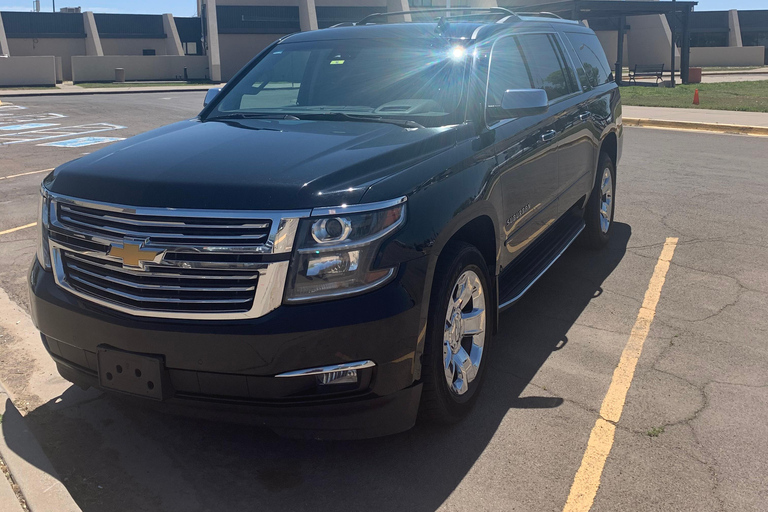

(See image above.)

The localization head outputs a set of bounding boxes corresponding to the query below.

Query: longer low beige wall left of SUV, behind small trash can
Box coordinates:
[72,55,209,82]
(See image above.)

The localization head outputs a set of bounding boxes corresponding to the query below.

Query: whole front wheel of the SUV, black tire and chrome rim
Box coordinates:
[421,243,492,423]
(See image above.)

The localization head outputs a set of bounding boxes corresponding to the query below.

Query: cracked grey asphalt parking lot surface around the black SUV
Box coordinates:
[0,92,768,512]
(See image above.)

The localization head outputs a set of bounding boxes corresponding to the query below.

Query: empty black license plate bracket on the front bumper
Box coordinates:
[97,347,166,400]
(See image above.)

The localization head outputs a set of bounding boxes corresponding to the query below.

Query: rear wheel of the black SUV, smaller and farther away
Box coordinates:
[583,153,616,249]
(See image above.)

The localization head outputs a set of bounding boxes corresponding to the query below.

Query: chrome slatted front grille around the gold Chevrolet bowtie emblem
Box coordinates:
[49,194,309,319]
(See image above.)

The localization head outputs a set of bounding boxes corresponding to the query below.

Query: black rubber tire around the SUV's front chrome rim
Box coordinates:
[420,242,493,424]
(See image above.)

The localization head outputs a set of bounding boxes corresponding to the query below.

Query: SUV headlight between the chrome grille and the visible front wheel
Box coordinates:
[285,198,405,302]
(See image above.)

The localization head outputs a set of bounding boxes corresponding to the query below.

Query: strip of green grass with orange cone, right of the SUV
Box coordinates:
[621,80,768,112]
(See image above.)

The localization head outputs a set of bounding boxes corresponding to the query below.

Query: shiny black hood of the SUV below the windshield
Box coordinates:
[45,119,456,210]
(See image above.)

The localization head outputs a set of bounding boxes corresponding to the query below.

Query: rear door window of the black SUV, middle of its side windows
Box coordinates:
[520,34,573,101]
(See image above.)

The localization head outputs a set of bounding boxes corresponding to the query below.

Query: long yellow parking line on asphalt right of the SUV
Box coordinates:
[563,238,677,512]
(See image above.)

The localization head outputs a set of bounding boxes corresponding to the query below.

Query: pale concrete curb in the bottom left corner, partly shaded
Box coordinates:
[0,386,81,512]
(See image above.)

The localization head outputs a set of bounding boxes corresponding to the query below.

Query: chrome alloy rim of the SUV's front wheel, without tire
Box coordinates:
[443,270,485,395]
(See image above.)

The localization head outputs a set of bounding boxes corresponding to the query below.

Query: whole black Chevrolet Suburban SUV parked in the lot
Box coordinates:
[29,9,622,438]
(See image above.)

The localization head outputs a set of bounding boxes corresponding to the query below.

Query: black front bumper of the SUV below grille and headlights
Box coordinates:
[29,259,425,438]
